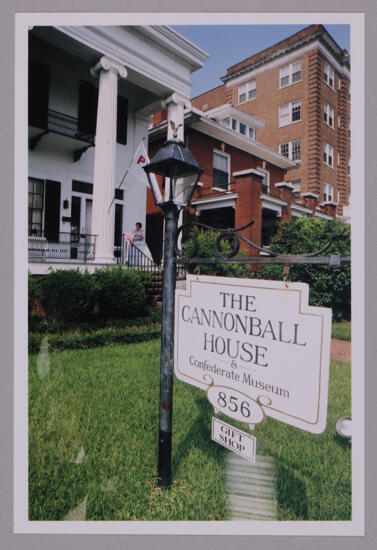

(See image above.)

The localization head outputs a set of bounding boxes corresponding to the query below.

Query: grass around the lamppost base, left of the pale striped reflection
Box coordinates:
[29,340,226,520]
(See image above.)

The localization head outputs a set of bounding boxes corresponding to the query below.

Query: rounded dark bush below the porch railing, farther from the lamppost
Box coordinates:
[38,269,98,321]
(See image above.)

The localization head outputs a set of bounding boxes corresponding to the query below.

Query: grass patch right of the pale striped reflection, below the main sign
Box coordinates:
[254,361,351,521]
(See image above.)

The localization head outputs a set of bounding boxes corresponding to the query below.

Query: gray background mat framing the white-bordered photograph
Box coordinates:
[0,0,377,550]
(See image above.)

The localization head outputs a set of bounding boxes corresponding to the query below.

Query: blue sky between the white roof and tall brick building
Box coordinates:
[173,25,350,97]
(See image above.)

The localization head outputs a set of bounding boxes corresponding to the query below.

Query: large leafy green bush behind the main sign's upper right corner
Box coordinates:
[256,218,351,321]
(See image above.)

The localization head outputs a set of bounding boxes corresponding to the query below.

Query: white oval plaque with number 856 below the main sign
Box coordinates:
[207,386,265,424]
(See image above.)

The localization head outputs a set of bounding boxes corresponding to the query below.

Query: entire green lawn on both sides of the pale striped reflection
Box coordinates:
[29,340,351,521]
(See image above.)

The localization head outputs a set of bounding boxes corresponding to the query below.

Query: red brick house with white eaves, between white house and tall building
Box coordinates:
[146,104,335,262]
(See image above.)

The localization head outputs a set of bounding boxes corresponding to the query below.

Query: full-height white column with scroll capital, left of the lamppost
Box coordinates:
[91,57,127,263]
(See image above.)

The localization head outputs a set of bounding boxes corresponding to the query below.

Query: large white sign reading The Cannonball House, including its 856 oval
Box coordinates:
[174,275,331,434]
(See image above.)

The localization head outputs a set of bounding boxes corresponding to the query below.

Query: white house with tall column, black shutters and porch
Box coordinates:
[28,26,208,273]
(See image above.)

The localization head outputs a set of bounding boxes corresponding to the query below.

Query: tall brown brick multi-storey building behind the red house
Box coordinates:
[192,25,350,215]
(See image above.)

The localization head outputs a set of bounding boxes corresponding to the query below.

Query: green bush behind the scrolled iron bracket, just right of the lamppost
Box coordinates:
[184,228,248,277]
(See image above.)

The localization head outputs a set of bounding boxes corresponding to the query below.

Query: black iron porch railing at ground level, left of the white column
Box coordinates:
[28,231,97,262]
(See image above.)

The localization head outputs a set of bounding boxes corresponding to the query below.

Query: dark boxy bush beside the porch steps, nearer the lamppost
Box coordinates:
[94,266,151,319]
